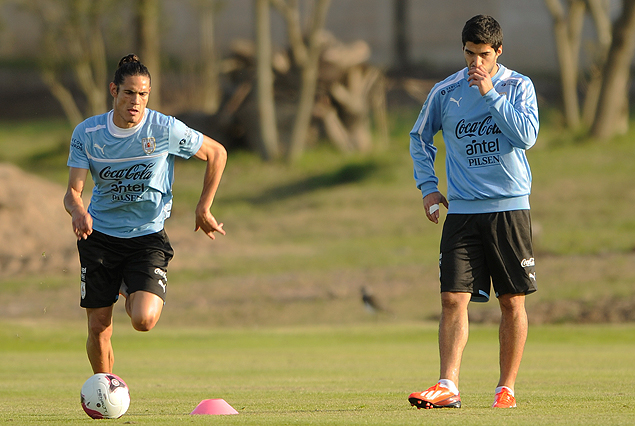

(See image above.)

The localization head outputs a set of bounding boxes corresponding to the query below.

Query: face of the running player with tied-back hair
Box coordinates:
[110,75,150,129]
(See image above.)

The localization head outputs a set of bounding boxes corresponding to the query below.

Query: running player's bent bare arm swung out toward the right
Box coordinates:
[194,136,227,239]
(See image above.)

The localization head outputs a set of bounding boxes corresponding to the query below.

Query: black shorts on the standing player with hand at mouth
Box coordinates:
[439,210,537,302]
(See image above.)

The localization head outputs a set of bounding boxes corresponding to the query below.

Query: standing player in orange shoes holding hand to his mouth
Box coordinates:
[409,15,539,408]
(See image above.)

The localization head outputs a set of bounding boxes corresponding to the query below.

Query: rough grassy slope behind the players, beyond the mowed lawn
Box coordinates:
[0,110,635,326]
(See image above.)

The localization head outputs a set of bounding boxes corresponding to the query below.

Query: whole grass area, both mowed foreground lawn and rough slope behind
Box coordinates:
[0,111,635,425]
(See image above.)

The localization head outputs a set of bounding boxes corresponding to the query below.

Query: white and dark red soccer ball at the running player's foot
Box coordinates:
[81,373,130,419]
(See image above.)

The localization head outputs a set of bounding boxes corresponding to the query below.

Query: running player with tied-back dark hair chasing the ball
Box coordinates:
[64,55,227,373]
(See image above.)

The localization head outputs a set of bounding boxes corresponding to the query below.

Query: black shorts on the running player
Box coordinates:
[77,230,174,308]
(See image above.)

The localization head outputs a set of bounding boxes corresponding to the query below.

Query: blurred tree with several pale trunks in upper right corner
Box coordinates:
[545,0,635,139]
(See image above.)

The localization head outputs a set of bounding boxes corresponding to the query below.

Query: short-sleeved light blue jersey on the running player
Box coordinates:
[67,108,203,238]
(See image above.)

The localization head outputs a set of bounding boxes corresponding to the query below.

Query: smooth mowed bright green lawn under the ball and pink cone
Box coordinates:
[0,322,635,426]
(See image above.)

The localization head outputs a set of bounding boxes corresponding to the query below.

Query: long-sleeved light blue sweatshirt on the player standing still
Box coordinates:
[410,64,539,213]
